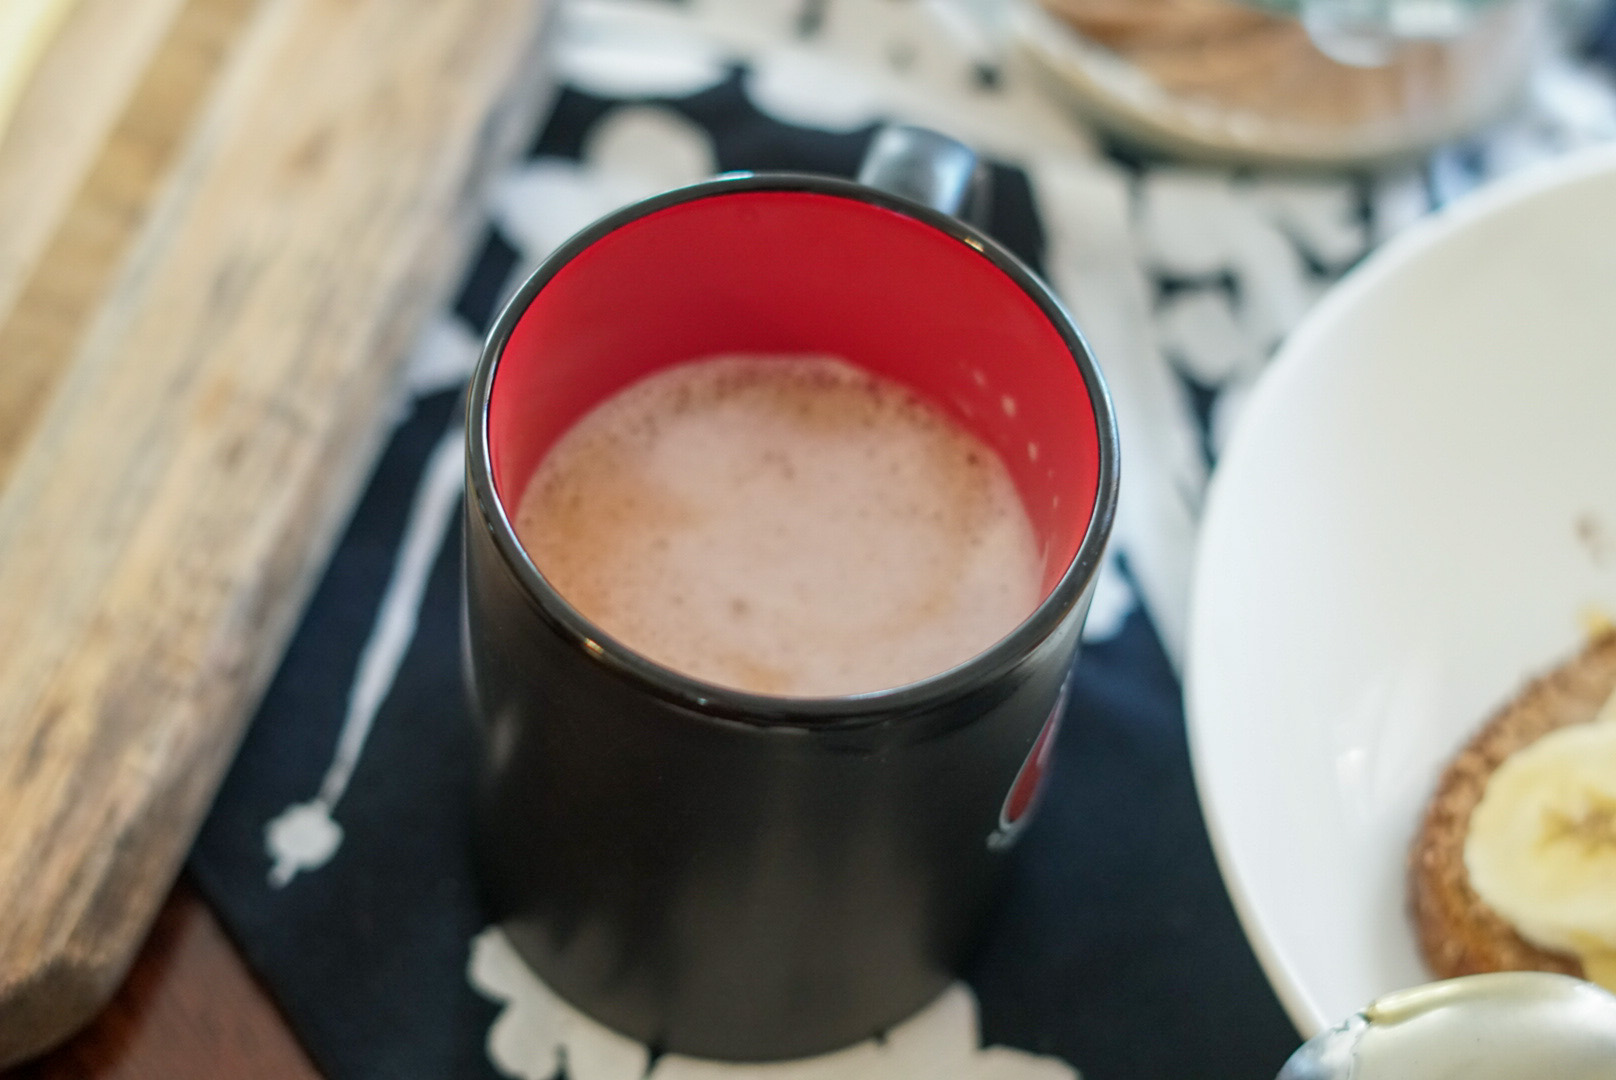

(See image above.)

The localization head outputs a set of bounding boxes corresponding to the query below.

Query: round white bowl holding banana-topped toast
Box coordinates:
[1185,150,1616,1035]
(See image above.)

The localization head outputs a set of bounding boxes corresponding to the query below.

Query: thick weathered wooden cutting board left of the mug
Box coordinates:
[0,0,548,1065]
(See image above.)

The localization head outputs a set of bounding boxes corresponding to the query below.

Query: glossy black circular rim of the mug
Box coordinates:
[465,171,1118,729]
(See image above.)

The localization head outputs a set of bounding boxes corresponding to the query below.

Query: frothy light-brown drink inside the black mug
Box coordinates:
[516,357,1042,697]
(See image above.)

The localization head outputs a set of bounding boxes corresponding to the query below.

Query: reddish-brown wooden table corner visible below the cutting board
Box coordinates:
[0,880,320,1080]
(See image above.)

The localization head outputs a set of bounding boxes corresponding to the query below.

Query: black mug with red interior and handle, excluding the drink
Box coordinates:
[465,128,1117,1061]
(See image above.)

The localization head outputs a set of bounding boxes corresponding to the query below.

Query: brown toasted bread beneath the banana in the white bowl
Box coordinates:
[1409,631,1616,978]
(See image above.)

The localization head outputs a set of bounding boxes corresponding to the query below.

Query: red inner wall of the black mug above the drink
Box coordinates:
[488,191,1100,607]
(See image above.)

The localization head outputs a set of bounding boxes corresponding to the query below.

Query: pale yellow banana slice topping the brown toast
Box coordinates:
[1464,695,1616,989]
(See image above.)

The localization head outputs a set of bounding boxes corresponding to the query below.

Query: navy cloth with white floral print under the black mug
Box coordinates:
[191,0,1616,1080]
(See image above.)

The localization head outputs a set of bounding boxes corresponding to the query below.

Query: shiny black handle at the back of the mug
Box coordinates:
[858,124,991,226]
